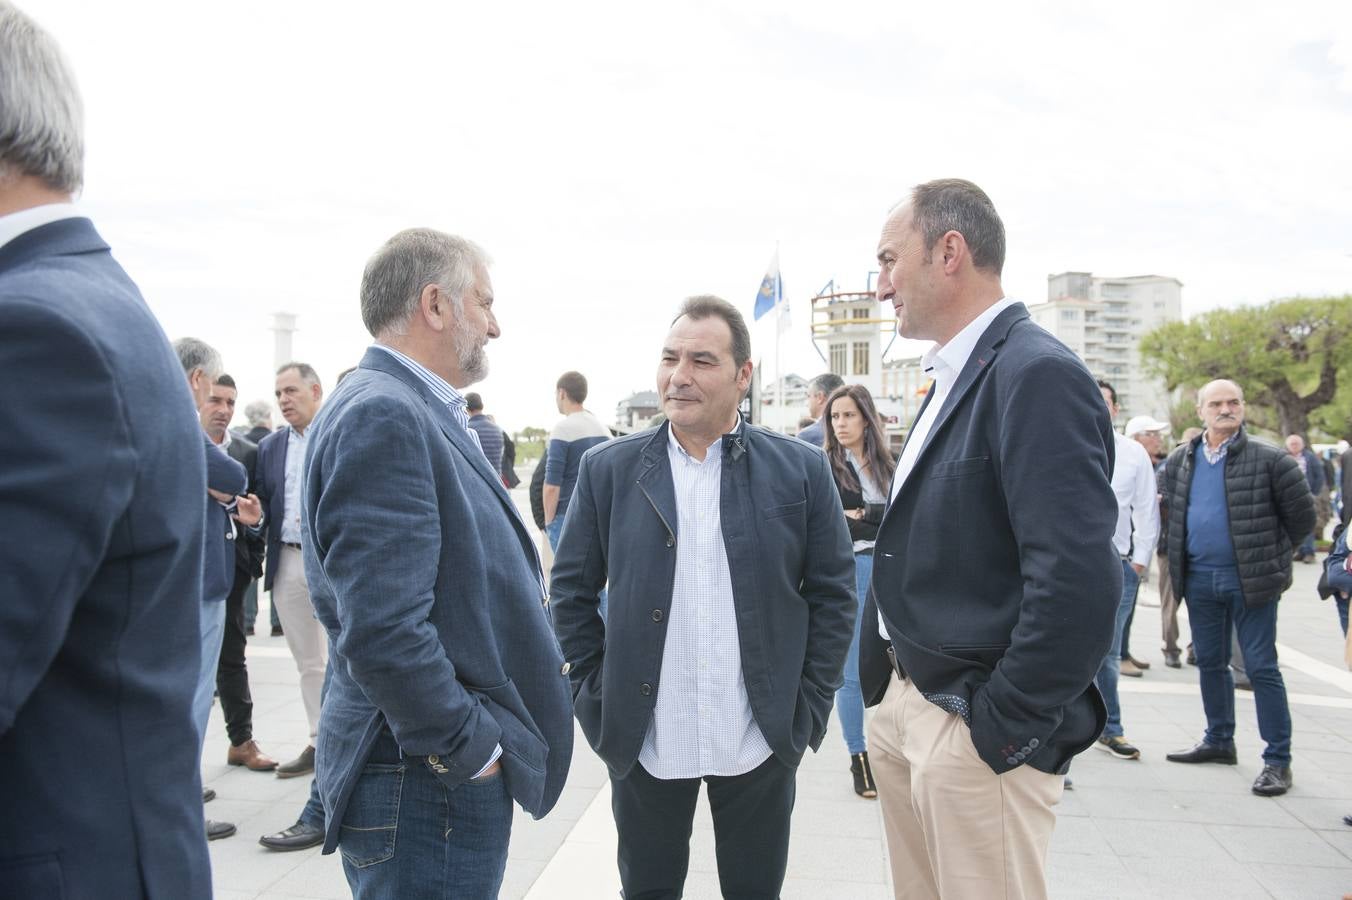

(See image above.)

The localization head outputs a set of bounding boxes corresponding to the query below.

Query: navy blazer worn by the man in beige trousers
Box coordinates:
[860,304,1122,773]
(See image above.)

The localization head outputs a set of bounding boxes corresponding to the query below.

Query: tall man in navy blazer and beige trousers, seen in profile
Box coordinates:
[860,180,1122,897]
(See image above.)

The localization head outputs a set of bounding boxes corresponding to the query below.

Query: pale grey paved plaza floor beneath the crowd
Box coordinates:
[201,481,1352,900]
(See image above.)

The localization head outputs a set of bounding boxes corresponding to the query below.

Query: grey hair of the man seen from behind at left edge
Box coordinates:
[0,0,84,193]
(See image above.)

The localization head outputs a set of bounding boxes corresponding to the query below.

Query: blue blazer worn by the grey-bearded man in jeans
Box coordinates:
[301,347,573,853]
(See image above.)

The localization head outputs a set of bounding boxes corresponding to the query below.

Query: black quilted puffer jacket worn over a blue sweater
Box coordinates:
[1161,426,1314,608]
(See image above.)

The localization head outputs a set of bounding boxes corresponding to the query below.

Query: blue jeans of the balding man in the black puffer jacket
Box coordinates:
[1183,568,1291,766]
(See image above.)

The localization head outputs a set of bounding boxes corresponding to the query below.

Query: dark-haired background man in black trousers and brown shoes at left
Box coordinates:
[200,374,277,772]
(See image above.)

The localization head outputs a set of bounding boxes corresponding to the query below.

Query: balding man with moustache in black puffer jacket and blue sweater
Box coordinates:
[1164,380,1314,797]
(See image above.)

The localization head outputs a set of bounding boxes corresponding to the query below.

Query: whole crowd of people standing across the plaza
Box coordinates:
[0,1,1352,899]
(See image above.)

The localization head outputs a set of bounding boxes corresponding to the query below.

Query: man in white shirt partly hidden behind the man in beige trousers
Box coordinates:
[1094,381,1160,759]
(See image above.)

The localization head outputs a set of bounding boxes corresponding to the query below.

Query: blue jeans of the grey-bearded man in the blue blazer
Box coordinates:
[338,734,512,900]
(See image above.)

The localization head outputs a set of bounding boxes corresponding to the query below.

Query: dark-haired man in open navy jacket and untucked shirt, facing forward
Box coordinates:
[550,296,856,900]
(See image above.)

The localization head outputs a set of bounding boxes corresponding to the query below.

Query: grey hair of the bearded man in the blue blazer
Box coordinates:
[361,228,489,338]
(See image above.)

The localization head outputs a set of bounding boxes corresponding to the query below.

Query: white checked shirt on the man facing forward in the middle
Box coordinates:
[638,426,771,778]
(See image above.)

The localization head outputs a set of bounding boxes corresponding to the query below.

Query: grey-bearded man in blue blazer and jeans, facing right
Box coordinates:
[301,228,573,900]
